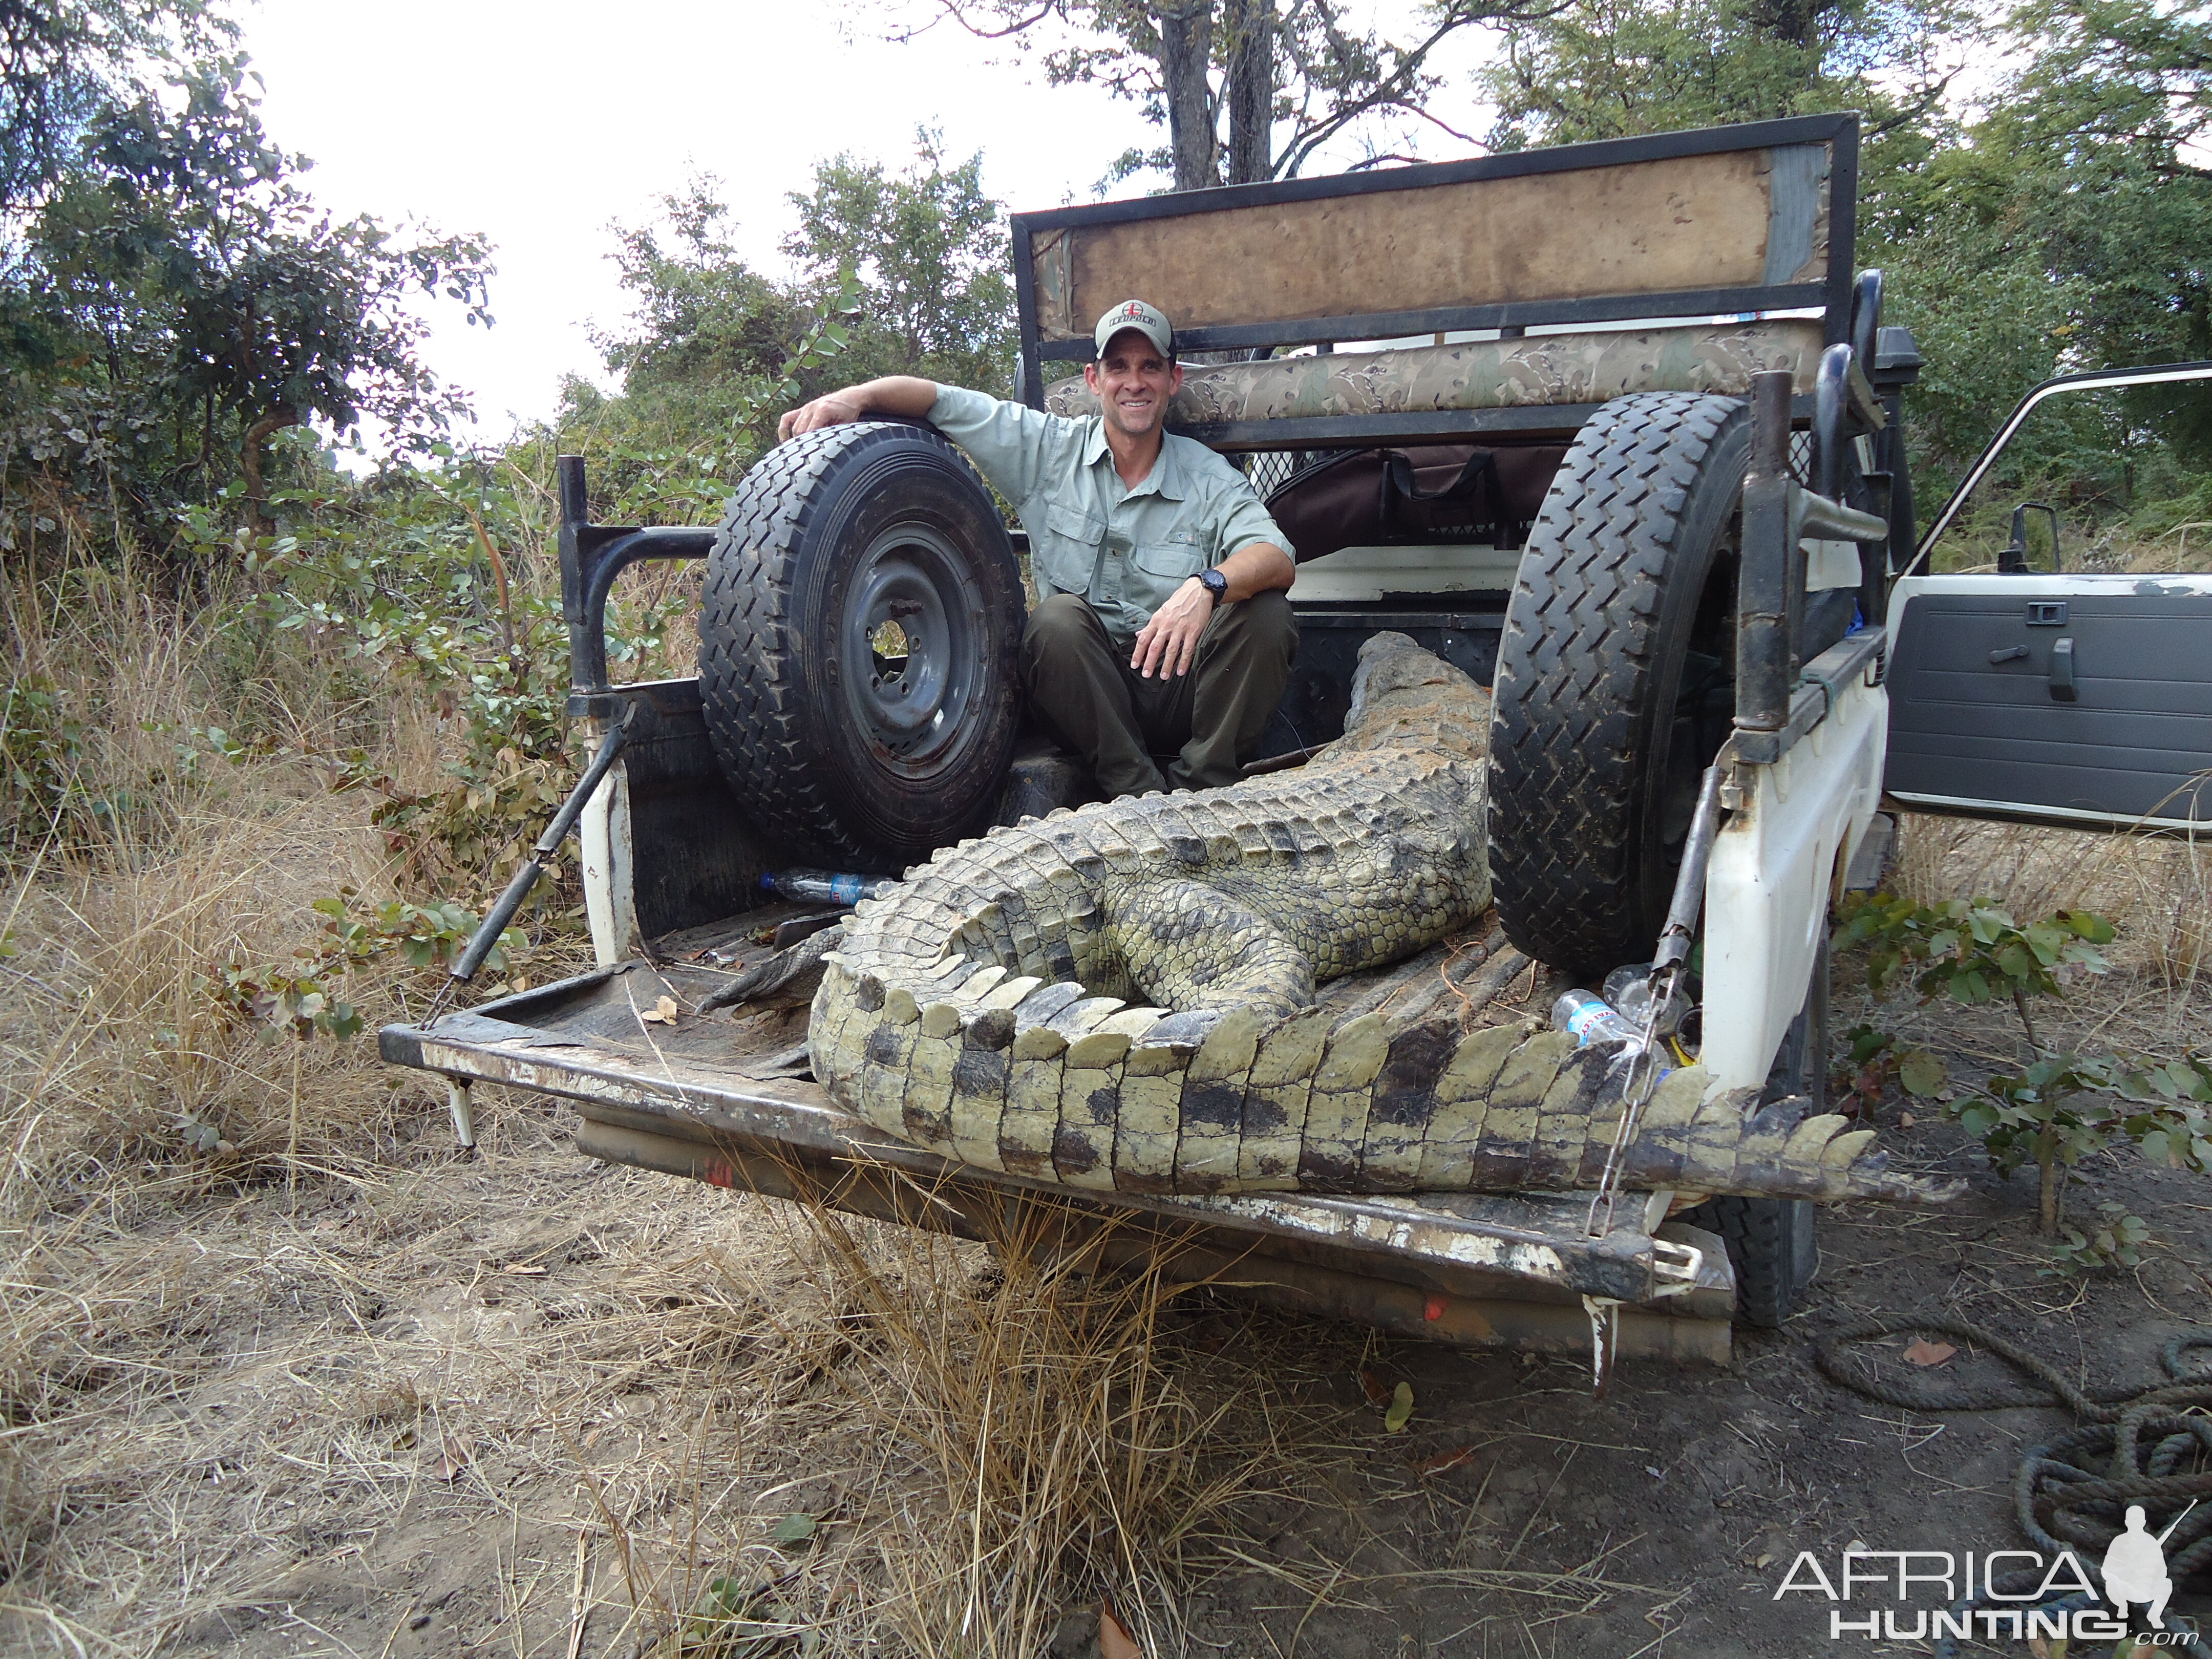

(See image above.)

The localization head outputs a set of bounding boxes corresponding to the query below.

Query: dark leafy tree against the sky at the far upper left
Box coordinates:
[0,37,491,559]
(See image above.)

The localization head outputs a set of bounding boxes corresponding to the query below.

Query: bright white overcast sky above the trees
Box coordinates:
[237,0,1482,438]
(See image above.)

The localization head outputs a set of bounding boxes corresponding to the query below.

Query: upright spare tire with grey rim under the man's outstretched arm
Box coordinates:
[699,420,1022,871]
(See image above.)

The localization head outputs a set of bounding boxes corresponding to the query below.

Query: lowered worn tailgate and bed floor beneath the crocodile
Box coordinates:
[380,905,1734,1363]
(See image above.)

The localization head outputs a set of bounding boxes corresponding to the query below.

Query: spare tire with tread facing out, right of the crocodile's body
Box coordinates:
[1491,392,1752,973]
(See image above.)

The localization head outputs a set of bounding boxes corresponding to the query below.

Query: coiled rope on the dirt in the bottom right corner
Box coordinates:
[1812,1314,2212,1659]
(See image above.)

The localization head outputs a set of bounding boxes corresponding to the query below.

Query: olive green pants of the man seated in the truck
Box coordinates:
[1022,590,1299,796]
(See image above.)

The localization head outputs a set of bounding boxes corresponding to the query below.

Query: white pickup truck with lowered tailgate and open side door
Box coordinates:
[380,115,2212,1363]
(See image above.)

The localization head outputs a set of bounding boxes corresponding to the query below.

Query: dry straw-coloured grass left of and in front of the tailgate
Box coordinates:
[0,528,1292,1654]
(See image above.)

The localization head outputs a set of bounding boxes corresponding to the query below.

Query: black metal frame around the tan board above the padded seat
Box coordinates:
[1011,113,1858,409]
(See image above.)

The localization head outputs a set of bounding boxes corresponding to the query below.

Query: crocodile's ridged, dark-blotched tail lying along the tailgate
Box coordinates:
[810,953,1951,1203]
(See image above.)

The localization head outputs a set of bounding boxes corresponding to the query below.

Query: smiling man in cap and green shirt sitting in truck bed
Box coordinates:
[779,299,1299,796]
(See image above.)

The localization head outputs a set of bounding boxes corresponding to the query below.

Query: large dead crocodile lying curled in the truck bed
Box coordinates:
[807,633,1940,1199]
